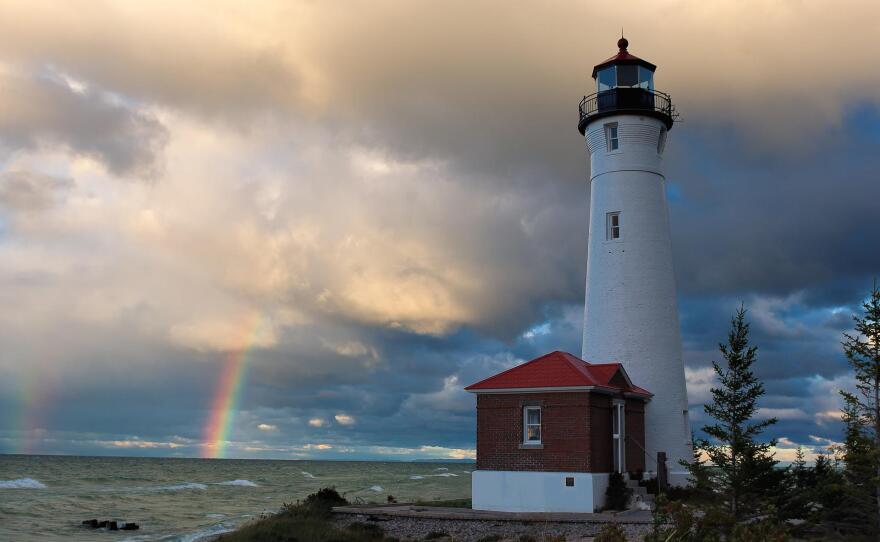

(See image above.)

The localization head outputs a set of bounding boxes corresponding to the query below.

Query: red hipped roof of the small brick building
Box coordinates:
[465,350,652,397]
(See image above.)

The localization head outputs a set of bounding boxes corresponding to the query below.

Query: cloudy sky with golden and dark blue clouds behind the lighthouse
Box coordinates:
[0,0,880,460]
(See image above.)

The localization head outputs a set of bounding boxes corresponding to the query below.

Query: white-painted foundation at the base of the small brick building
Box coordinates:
[471,470,609,513]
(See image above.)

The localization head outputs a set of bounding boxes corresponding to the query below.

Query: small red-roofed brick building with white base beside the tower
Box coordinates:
[465,351,651,512]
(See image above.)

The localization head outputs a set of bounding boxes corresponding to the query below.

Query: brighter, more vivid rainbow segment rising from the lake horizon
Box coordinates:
[202,314,263,458]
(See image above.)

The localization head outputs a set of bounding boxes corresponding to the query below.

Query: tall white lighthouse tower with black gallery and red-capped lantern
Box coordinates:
[578,38,693,484]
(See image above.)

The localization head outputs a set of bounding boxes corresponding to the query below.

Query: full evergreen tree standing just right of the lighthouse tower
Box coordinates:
[689,306,784,521]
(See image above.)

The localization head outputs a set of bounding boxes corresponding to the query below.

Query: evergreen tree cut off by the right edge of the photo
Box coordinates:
[840,280,880,531]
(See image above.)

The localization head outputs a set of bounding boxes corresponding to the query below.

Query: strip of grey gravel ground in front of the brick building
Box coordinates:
[332,513,651,542]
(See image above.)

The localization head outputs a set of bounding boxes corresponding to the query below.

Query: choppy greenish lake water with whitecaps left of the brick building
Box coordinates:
[0,455,474,542]
